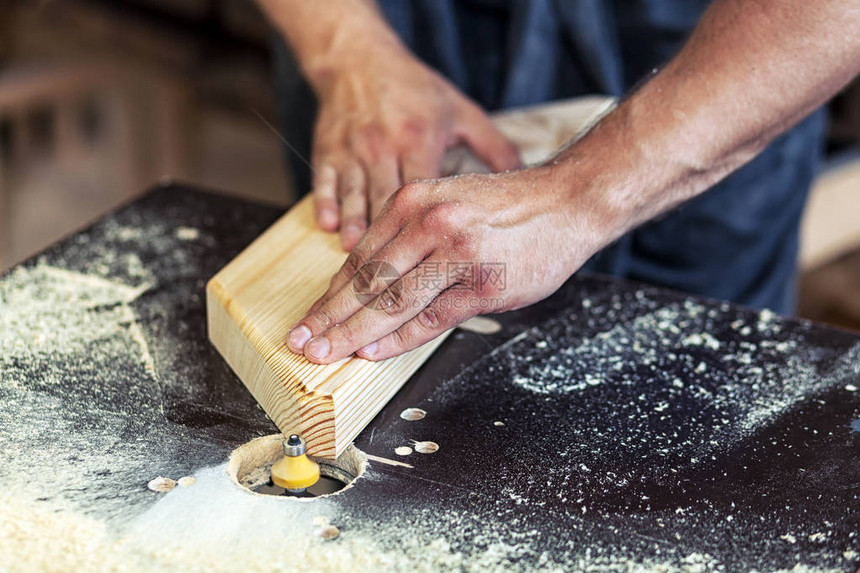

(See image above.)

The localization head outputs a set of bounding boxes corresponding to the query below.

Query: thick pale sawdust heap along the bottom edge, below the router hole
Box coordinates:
[0,460,815,573]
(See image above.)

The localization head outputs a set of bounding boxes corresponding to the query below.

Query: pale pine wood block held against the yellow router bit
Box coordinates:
[206,196,447,458]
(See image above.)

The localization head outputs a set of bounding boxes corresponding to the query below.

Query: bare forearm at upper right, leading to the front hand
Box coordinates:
[555,0,860,243]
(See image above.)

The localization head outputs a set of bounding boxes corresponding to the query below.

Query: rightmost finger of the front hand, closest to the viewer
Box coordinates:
[355,289,479,360]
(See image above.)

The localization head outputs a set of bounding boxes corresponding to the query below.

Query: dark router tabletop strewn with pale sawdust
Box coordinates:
[0,184,860,572]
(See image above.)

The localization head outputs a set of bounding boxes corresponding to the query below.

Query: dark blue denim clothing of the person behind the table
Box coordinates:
[276,0,825,313]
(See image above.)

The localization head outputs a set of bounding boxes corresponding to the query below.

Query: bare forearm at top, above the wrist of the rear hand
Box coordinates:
[257,0,403,92]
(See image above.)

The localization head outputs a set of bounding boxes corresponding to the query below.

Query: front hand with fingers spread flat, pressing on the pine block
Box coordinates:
[289,166,602,364]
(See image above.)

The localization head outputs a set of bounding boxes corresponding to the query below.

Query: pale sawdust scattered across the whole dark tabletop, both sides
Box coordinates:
[0,198,860,572]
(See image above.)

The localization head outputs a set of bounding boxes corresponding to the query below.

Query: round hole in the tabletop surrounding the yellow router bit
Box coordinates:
[227,434,367,500]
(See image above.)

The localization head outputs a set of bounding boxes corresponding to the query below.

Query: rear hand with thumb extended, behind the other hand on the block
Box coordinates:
[312,45,520,250]
